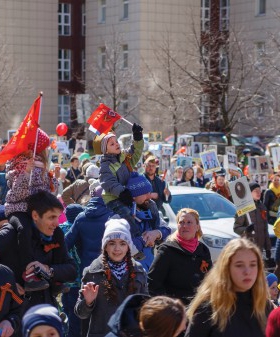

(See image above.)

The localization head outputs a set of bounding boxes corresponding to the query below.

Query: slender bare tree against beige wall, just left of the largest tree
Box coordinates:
[141,32,197,151]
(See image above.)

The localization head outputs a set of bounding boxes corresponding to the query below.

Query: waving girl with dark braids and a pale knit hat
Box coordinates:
[74,219,147,337]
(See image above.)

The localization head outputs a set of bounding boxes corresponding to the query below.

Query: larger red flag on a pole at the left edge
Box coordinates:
[0,95,42,164]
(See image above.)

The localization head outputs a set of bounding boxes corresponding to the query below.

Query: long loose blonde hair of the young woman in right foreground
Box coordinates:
[187,238,269,332]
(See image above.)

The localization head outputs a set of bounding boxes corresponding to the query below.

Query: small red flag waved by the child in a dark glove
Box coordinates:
[87,103,122,135]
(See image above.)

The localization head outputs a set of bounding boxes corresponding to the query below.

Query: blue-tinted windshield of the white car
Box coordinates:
[170,193,236,220]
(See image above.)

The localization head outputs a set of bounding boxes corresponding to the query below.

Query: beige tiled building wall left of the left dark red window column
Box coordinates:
[0,0,58,138]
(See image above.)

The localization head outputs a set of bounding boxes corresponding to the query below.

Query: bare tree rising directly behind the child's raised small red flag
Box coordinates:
[86,28,139,134]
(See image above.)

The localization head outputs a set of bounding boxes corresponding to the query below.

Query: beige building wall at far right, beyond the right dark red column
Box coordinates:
[230,0,280,135]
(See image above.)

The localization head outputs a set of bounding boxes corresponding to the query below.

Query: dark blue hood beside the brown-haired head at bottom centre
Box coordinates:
[105,294,150,337]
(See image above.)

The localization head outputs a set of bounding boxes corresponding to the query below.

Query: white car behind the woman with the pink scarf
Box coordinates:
[163,186,276,262]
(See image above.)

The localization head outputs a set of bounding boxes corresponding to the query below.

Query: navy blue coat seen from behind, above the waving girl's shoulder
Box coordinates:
[65,197,114,274]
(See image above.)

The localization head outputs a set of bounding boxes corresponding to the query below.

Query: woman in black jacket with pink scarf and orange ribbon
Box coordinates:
[148,208,212,304]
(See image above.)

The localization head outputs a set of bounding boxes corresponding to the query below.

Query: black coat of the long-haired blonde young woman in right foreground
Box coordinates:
[185,290,272,337]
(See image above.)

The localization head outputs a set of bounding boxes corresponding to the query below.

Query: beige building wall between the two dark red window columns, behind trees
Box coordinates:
[86,0,200,135]
